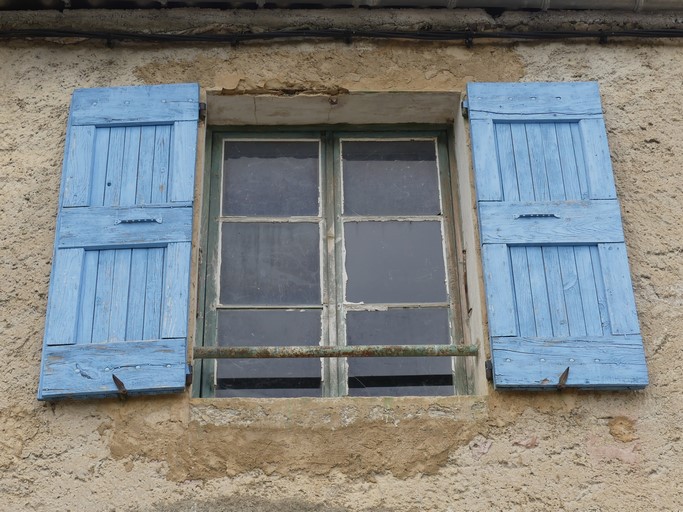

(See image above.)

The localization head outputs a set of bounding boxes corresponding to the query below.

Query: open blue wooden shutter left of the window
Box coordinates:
[38,84,199,400]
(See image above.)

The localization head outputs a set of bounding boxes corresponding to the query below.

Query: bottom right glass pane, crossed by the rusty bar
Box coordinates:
[346,308,453,396]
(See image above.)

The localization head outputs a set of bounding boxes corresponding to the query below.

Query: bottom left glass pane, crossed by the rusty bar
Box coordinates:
[216,310,321,397]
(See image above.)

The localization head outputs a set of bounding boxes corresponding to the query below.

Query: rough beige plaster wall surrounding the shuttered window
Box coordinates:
[0,10,683,512]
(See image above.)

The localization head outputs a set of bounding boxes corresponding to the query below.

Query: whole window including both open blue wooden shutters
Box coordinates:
[38,83,648,400]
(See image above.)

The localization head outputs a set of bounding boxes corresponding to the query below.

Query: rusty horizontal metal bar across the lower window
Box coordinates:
[193,345,479,359]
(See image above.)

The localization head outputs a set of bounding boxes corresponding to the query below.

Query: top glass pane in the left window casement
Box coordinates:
[222,141,319,217]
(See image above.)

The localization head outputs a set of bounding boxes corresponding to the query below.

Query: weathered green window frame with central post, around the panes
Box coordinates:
[193,125,475,398]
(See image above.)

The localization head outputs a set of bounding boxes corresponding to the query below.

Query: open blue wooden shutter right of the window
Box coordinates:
[468,83,648,389]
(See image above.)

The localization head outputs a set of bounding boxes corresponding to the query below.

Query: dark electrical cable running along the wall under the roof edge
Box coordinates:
[0,29,683,47]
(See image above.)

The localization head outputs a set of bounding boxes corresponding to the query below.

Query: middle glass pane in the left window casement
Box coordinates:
[220,222,320,305]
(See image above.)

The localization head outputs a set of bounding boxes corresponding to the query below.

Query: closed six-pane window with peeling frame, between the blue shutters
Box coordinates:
[196,128,470,397]
